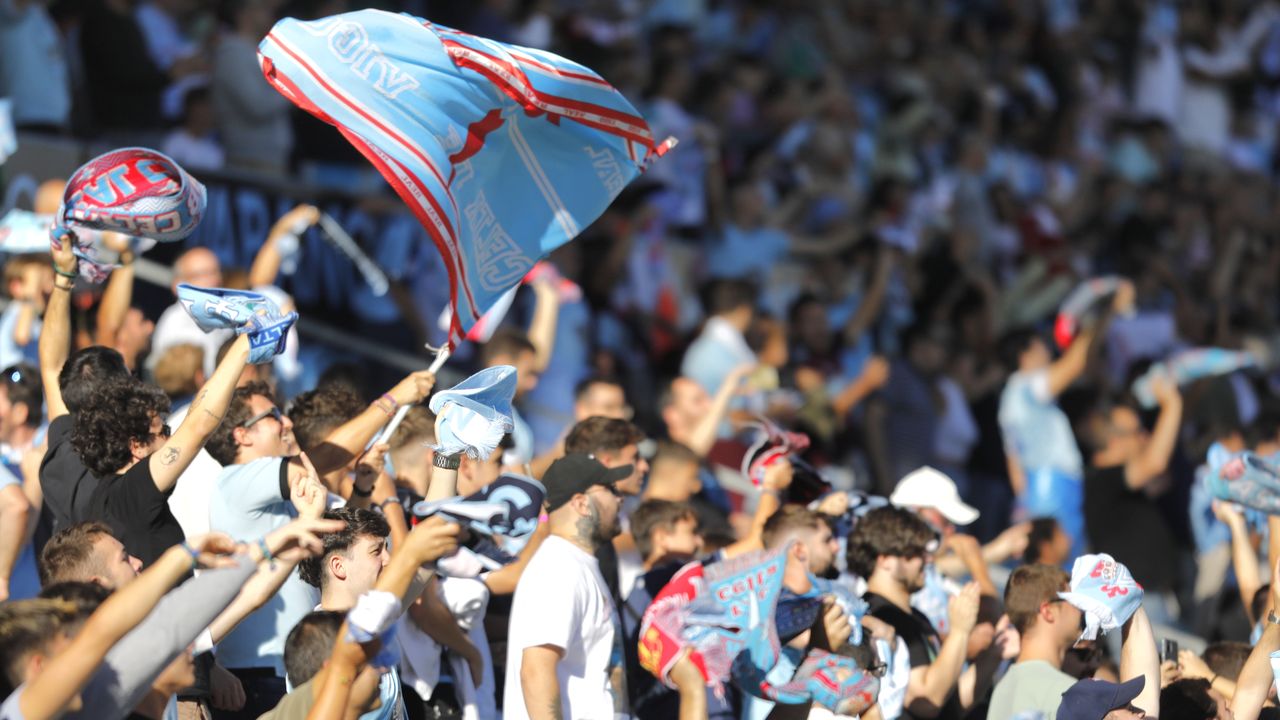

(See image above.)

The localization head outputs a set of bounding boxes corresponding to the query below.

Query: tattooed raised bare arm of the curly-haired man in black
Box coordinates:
[147,334,248,492]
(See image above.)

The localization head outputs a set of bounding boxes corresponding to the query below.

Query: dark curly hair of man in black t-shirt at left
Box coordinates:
[72,378,169,478]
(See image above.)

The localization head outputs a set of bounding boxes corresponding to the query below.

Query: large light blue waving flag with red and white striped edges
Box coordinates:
[259,10,673,346]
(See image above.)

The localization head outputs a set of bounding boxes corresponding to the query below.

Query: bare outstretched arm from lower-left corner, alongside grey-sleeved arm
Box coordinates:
[18,534,236,720]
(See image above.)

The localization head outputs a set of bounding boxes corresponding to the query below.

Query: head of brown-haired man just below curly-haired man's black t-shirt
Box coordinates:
[40,521,142,589]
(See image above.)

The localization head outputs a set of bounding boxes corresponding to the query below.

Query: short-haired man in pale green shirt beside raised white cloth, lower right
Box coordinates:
[987,564,1084,720]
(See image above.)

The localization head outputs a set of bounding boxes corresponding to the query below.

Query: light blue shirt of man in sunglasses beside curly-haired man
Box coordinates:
[209,457,320,678]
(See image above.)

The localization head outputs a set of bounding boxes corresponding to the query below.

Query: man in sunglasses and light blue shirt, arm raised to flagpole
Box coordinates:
[207,372,435,719]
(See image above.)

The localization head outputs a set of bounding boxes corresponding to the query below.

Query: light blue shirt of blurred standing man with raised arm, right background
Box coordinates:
[1000,368,1084,478]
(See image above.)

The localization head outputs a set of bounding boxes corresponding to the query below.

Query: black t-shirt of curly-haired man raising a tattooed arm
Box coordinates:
[90,457,183,566]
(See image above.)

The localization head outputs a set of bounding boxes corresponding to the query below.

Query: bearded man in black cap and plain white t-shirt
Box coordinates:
[503,455,632,720]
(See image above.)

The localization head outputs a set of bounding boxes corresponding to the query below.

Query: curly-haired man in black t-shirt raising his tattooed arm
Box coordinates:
[72,336,259,566]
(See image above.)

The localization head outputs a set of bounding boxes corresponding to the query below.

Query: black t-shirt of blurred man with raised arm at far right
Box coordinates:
[1084,465,1178,591]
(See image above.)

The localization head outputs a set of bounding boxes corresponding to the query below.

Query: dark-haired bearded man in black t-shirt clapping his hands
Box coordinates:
[849,506,979,719]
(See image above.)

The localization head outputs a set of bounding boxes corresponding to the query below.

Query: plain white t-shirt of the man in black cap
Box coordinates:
[503,536,616,720]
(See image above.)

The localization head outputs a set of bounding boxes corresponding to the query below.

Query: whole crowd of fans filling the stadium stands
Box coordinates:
[0,0,1280,720]
